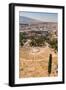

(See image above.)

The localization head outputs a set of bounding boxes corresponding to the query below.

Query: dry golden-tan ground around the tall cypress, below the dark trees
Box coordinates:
[19,46,58,78]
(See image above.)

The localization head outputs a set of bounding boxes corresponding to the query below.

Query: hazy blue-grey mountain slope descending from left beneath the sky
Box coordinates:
[19,16,42,24]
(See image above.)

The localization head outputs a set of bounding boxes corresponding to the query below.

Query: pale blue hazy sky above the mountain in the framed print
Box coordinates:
[19,11,58,22]
